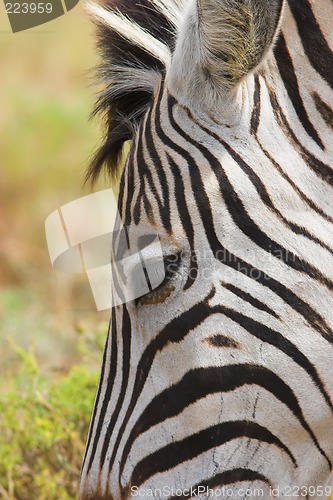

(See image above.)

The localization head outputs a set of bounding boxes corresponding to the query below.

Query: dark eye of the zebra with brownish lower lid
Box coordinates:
[135,254,181,305]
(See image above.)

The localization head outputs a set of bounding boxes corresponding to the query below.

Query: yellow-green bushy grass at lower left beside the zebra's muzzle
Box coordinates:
[0,324,105,500]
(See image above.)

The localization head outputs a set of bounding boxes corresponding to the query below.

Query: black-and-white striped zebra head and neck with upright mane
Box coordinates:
[79,0,333,500]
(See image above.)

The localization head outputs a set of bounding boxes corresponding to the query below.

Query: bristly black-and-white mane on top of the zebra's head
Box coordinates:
[87,0,183,182]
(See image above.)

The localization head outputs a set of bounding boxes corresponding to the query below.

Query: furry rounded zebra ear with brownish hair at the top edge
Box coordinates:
[169,0,284,101]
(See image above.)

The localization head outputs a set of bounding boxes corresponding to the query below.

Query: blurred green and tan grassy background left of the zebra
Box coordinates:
[0,2,108,500]
